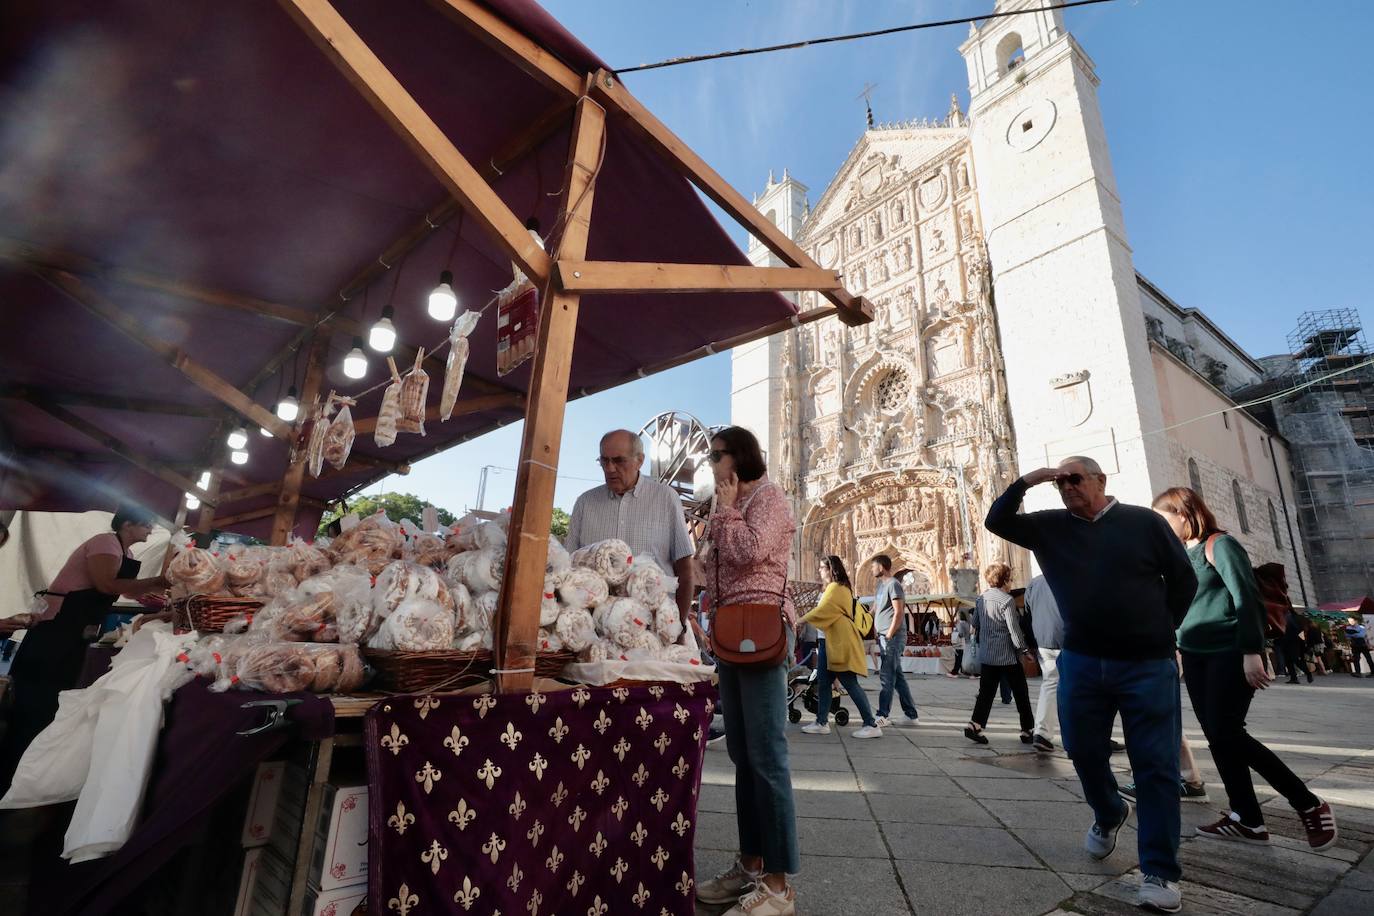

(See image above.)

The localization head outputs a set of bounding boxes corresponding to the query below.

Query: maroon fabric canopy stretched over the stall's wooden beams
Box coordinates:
[0,0,794,533]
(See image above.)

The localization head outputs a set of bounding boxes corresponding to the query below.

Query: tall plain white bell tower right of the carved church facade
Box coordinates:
[959,0,1172,508]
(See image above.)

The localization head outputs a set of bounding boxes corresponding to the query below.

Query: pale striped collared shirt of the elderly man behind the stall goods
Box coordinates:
[563,474,692,574]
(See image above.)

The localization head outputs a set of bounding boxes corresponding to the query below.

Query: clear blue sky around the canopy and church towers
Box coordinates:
[357,0,1374,512]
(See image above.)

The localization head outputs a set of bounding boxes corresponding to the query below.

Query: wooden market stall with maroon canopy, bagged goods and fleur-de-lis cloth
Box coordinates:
[0,0,871,913]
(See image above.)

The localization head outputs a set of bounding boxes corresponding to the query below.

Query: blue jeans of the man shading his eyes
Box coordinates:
[1059,650,1183,882]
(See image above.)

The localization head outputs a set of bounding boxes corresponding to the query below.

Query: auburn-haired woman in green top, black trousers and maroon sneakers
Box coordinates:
[1154,486,1337,849]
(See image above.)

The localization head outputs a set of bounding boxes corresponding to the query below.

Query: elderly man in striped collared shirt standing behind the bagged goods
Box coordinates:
[563,430,692,621]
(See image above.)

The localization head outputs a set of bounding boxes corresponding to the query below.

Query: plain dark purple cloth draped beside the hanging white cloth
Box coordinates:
[29,680,334,916]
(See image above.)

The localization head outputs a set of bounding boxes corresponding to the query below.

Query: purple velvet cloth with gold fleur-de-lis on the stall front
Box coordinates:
[365,684,716,916]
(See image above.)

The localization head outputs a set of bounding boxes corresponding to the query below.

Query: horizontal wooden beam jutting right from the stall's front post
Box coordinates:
[554,260,844,295]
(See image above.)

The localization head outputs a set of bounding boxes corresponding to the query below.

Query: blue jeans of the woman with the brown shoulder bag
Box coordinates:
[717,634,801,875]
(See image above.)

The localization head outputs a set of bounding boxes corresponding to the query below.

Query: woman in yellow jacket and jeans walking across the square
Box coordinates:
[801,556,882,737]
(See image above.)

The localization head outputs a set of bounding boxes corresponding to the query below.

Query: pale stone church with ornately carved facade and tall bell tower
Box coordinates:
[731,0,1305,592]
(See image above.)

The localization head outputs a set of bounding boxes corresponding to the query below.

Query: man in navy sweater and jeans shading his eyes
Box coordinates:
[985,457,1197,913]
